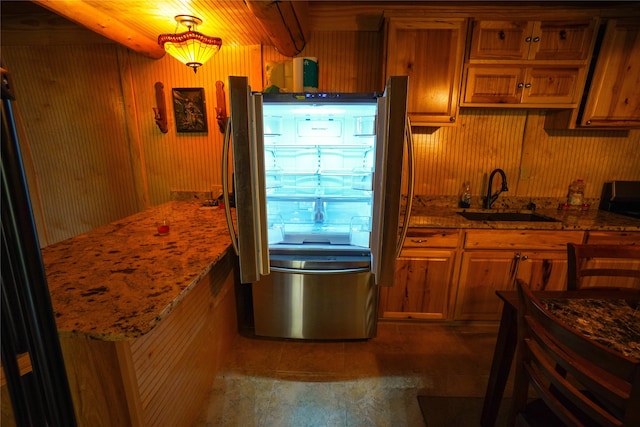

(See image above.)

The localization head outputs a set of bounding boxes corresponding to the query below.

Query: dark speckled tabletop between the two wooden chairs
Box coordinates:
[542,299,640,360]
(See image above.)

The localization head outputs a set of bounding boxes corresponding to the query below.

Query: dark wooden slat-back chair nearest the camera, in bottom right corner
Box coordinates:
[510,281,640,426]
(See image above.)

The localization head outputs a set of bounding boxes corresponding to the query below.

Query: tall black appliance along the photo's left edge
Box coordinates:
[0,67,77,427]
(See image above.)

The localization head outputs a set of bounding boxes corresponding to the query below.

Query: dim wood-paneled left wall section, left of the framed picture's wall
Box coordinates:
[2,44,138,246]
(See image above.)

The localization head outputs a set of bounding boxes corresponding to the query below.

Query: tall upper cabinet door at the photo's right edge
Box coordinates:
[580,18,640,128]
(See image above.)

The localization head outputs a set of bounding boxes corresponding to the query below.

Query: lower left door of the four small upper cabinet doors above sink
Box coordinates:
[463,64,524,105]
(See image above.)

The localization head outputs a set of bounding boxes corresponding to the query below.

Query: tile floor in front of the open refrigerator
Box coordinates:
[194,321,508,427]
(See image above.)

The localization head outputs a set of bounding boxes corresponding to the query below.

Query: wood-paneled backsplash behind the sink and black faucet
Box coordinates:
[413,108,640,202]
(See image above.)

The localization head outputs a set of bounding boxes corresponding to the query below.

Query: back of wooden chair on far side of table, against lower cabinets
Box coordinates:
[567,243,640,290]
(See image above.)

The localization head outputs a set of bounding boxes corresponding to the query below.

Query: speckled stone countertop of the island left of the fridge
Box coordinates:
[42,202,232,341]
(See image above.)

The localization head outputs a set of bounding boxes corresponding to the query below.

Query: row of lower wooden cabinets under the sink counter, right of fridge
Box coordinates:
[379,228,640,321]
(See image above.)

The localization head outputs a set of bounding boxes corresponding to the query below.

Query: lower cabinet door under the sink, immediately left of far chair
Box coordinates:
[516,251,567,291]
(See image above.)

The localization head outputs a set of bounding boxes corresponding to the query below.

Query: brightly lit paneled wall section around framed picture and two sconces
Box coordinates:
[129,46,262,205]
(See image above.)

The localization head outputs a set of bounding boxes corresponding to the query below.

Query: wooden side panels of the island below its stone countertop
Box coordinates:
[61,253,237,427]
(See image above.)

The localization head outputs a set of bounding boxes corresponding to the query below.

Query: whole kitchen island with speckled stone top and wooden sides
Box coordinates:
[42,202,237,426]
